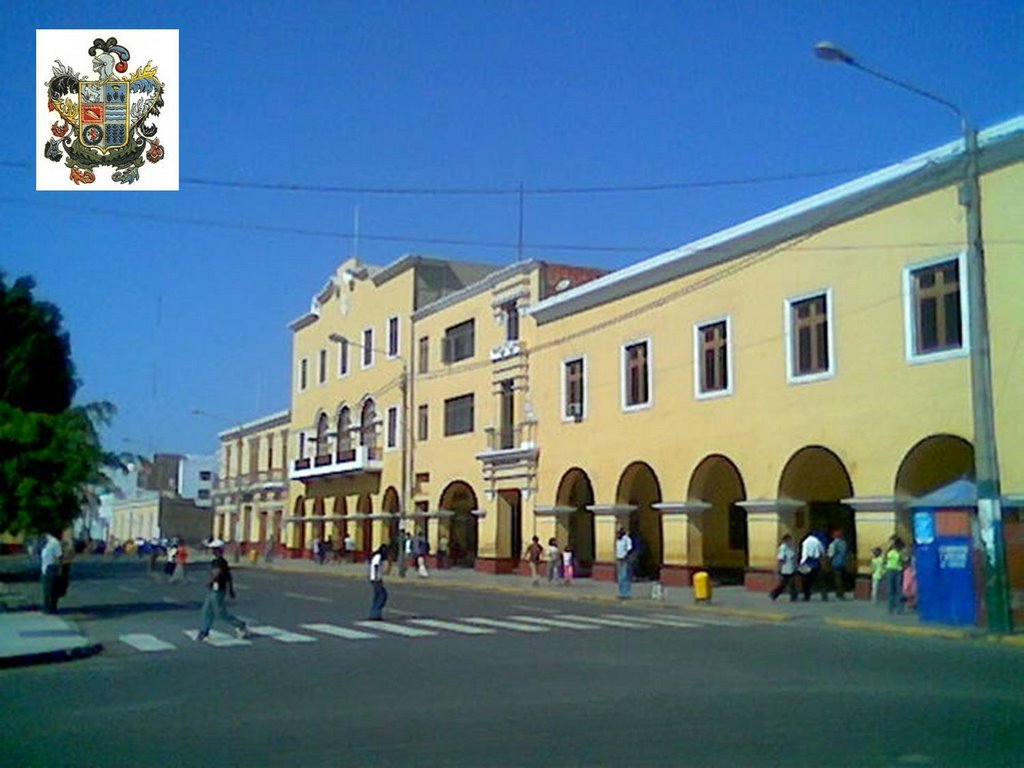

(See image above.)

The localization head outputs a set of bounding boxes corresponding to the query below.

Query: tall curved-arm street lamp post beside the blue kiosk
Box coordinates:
[814,42,1013,633]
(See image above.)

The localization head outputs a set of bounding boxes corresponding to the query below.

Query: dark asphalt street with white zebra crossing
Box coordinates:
[0,561,1024,768]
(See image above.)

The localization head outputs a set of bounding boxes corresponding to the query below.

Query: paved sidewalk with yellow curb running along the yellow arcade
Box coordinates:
[241,558,1024,647]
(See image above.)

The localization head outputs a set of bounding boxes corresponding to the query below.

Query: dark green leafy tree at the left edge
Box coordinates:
[0,272,124,534]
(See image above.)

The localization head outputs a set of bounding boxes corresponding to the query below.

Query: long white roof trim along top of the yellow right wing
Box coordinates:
[529,116,1024,324]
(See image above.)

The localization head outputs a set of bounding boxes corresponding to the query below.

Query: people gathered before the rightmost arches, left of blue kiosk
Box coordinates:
[768,529,916,613]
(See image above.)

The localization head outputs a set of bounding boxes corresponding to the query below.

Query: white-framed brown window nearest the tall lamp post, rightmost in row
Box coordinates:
[909,259,965,356]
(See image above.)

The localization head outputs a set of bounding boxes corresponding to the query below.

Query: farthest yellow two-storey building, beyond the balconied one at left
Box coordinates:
[212,411,290,554]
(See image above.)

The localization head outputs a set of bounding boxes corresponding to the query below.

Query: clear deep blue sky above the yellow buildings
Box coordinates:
[0,0,1024,454]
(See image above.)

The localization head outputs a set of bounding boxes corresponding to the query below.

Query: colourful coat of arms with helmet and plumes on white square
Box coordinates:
[43,37,165,184]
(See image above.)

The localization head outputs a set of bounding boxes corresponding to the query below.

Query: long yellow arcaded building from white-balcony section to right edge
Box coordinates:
[286,114,1024,622]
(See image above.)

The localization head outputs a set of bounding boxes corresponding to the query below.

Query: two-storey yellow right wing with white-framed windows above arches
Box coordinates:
[529,114,1024,598]
